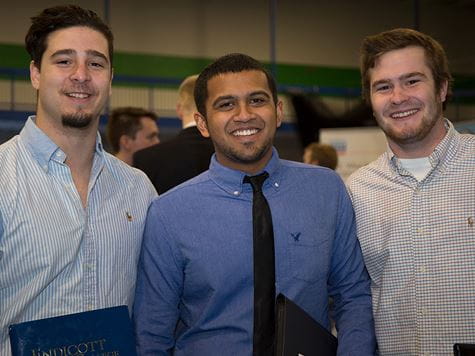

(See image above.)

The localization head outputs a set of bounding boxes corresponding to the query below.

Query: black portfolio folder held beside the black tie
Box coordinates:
[275,294,338,356]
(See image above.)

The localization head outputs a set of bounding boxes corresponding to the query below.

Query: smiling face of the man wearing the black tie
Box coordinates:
[195,70,282,174]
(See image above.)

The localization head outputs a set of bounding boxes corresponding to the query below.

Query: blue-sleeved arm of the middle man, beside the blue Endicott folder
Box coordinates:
[133,200,183,355]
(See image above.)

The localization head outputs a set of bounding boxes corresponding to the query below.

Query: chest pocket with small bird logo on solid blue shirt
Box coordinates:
[287,230,330,283]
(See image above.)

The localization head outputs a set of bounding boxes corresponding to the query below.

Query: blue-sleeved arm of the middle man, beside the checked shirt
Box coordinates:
[329,187,376,356]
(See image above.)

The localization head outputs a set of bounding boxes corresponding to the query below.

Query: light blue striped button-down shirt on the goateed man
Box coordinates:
[0,117,157,356]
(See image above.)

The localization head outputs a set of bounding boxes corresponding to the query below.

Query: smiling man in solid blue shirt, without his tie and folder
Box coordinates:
[134,54,375,356]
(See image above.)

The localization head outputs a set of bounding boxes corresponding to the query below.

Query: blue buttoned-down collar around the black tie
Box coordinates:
[209,147,281,196]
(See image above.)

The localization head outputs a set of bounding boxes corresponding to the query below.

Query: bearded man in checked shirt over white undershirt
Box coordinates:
[348,29,475,355]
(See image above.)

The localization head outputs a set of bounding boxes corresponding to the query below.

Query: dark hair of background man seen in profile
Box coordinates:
[106,106,158,154]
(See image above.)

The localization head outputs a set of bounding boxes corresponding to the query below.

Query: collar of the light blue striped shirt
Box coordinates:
[20,115,104,172]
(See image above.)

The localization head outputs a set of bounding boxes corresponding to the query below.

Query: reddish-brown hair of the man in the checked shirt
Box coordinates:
[360,28,453,108]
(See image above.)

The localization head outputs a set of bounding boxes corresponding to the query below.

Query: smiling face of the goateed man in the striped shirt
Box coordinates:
[30,26,112,128]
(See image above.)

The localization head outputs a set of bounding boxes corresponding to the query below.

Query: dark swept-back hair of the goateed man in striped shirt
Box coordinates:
[25,5,114,69]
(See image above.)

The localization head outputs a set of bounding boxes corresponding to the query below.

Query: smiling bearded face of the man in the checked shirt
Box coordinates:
[370,46,447,158]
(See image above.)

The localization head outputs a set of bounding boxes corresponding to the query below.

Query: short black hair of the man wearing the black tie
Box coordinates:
[194,53,277,118]
